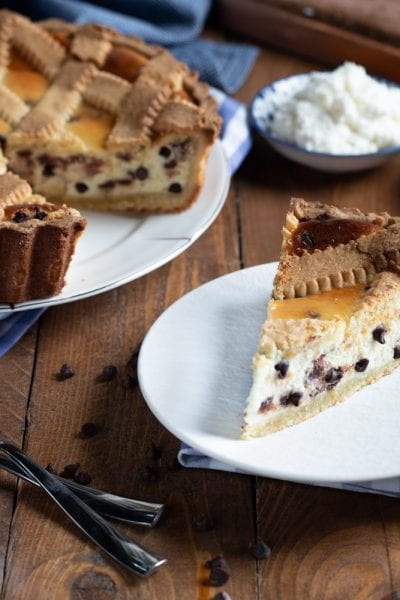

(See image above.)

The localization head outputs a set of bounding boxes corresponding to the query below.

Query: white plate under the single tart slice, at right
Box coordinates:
[138,263,400,482]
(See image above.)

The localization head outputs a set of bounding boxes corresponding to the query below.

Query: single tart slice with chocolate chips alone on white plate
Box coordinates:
[242,200,400,439]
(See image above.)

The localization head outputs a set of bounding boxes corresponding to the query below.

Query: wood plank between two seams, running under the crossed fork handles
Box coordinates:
[4,194,256,600]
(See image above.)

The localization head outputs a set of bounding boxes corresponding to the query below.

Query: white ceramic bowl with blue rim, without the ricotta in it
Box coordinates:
[249,73,400,173]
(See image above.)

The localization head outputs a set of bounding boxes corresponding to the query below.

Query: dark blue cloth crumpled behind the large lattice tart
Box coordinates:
[2,0,259,94]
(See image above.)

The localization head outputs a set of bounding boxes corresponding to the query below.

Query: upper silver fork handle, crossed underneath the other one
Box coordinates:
[0,456,164,527]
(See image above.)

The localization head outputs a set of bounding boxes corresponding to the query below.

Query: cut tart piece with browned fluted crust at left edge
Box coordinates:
[0,172,86,304]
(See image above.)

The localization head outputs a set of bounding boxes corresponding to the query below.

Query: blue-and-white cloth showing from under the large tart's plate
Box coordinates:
[0,89,251,356]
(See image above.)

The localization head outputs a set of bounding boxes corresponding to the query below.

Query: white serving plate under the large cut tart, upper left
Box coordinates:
[0,141,230,318]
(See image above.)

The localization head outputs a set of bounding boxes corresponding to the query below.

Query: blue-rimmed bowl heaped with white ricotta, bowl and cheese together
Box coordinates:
[250,62,400,171]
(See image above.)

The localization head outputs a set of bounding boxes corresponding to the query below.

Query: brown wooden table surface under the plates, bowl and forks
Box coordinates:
[0,36,400,600]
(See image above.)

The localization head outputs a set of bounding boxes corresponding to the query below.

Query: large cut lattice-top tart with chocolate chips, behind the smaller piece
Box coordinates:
[0,10,221,212]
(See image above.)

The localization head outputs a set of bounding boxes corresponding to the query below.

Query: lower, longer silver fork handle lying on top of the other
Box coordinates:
[0,440,166,576]
